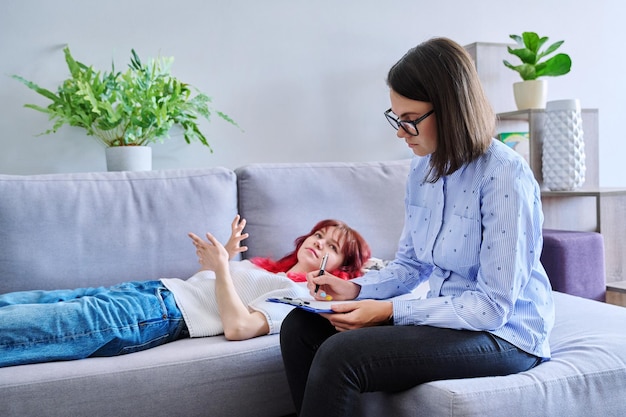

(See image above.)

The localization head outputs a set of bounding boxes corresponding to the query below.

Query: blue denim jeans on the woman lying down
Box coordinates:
[0,281,186,367]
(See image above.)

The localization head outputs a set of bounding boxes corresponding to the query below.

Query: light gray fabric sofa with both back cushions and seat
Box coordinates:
[0,161,626,417]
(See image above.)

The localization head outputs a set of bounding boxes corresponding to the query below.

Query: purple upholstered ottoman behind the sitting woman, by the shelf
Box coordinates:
[541,229,606,301]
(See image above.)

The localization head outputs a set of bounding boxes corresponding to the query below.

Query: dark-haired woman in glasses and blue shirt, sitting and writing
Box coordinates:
[280,38,554,417]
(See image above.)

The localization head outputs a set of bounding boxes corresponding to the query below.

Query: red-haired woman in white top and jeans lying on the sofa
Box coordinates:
[0,216,370,367]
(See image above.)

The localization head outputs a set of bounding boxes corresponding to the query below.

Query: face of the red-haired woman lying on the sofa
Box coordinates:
[296,226,344,272]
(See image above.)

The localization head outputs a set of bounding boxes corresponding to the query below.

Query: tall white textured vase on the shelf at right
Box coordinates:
[541,99,585,191]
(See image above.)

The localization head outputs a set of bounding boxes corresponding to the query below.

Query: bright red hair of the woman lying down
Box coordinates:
[250,219,372,282]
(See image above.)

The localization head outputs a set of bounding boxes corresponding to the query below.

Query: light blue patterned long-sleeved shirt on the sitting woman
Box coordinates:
[354,139,554,359]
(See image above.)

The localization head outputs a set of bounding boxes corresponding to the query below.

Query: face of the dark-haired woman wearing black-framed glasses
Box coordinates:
[389,90,437,156]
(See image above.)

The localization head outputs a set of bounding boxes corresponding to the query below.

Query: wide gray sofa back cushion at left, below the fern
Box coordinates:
[0,168,237,293]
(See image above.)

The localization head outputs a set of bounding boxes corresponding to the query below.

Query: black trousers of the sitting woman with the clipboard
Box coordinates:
[280,309,541,417]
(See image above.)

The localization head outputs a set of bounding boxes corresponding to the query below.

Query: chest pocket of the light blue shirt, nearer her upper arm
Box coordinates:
[439,215,482,267]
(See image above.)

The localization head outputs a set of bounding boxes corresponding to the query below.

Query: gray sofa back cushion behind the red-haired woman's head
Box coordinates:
[235,160,410,259]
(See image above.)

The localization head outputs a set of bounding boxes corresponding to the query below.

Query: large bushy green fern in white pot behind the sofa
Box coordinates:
[13,47,237,170]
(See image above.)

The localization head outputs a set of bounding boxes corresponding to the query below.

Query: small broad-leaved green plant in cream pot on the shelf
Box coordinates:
[503,32,572,110]
